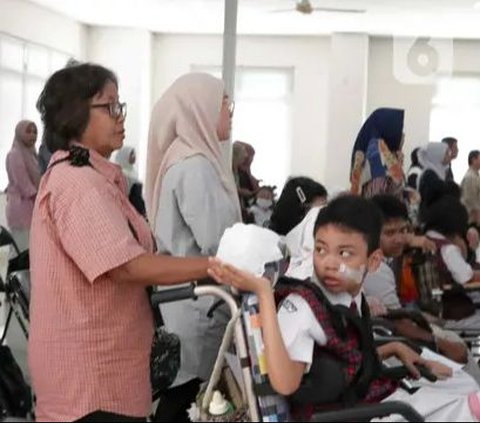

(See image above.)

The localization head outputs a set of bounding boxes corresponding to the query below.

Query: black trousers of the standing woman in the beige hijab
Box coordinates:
[153,379,202,422]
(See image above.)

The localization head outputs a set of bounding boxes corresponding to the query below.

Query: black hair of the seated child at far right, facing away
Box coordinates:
[424,195,468,236]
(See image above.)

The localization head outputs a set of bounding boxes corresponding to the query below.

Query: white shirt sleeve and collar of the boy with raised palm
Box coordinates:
[278,278,362,368]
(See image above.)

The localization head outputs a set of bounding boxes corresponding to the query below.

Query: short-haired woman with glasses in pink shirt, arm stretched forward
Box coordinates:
[29,64,212,422]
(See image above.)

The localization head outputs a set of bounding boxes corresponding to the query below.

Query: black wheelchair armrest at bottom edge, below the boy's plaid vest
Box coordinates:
[311,401,425,422]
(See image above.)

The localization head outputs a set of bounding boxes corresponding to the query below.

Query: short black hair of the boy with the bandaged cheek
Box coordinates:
[314,195,383,254]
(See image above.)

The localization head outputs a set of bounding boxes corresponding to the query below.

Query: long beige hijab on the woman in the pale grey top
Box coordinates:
[145,73,241,223]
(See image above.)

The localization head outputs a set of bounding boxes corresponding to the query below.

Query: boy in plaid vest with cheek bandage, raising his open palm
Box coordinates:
[209,196,480,421]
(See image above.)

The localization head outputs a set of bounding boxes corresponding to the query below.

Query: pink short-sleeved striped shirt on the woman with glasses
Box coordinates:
[29,150,154,421]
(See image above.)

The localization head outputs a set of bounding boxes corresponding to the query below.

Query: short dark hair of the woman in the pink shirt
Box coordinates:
[37,63,118,153]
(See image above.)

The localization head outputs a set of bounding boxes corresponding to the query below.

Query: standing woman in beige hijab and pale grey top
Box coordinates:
[145,73,241,421]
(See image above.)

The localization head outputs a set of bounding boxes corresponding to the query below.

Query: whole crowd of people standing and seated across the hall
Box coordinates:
[6,63,480,421]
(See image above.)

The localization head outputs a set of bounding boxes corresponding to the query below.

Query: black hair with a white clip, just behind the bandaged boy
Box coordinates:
[270,177,328,235]
